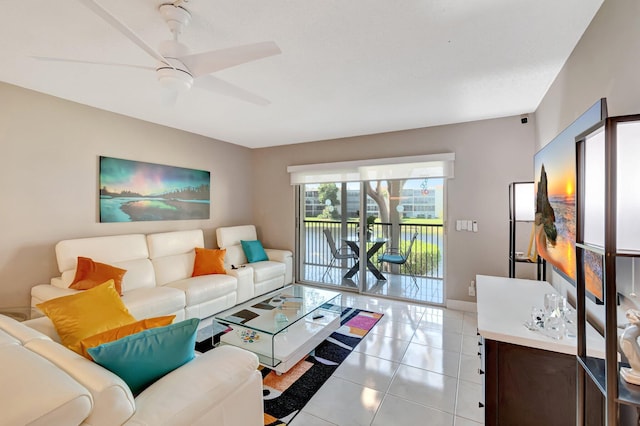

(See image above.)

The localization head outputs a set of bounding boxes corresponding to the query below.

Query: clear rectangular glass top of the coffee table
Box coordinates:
[215,285,340,335]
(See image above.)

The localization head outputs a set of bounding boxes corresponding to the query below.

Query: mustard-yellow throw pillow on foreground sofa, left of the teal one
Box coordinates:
[36,280,136,353]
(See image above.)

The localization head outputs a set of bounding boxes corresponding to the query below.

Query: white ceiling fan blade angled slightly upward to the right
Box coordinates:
[178,41,282,77]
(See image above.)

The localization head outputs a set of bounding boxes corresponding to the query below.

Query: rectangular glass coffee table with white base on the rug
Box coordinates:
[214,285,342,373]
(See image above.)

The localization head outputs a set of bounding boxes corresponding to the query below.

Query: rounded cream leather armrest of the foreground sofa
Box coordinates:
[127,346,264,425]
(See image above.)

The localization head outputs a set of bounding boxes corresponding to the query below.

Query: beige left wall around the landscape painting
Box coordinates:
[0,83,253,306]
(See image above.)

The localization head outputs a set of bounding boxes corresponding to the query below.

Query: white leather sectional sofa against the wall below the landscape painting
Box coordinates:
[31,225,293,322]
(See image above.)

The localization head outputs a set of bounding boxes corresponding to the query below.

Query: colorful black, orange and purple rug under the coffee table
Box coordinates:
[261,308,382,426]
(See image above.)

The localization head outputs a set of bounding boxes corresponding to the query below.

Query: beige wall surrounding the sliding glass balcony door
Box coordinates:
[253,117,535,301]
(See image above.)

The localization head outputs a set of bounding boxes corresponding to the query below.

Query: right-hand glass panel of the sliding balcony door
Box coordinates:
[362,178,445,304]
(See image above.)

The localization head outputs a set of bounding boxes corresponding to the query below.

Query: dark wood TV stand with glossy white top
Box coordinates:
[476,275,604,426]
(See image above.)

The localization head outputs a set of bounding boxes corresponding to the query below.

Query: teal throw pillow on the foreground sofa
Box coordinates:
[88,318,200,395]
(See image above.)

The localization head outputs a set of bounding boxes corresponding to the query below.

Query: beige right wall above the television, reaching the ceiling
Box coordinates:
[536,0,640,148]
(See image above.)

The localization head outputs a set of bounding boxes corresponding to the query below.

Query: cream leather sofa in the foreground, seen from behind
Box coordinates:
[0,315,263,426]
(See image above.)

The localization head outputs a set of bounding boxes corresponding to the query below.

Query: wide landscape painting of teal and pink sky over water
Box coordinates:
[99,156,211,222]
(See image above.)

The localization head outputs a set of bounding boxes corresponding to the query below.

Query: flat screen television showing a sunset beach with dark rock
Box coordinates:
[533,98,607,303]
